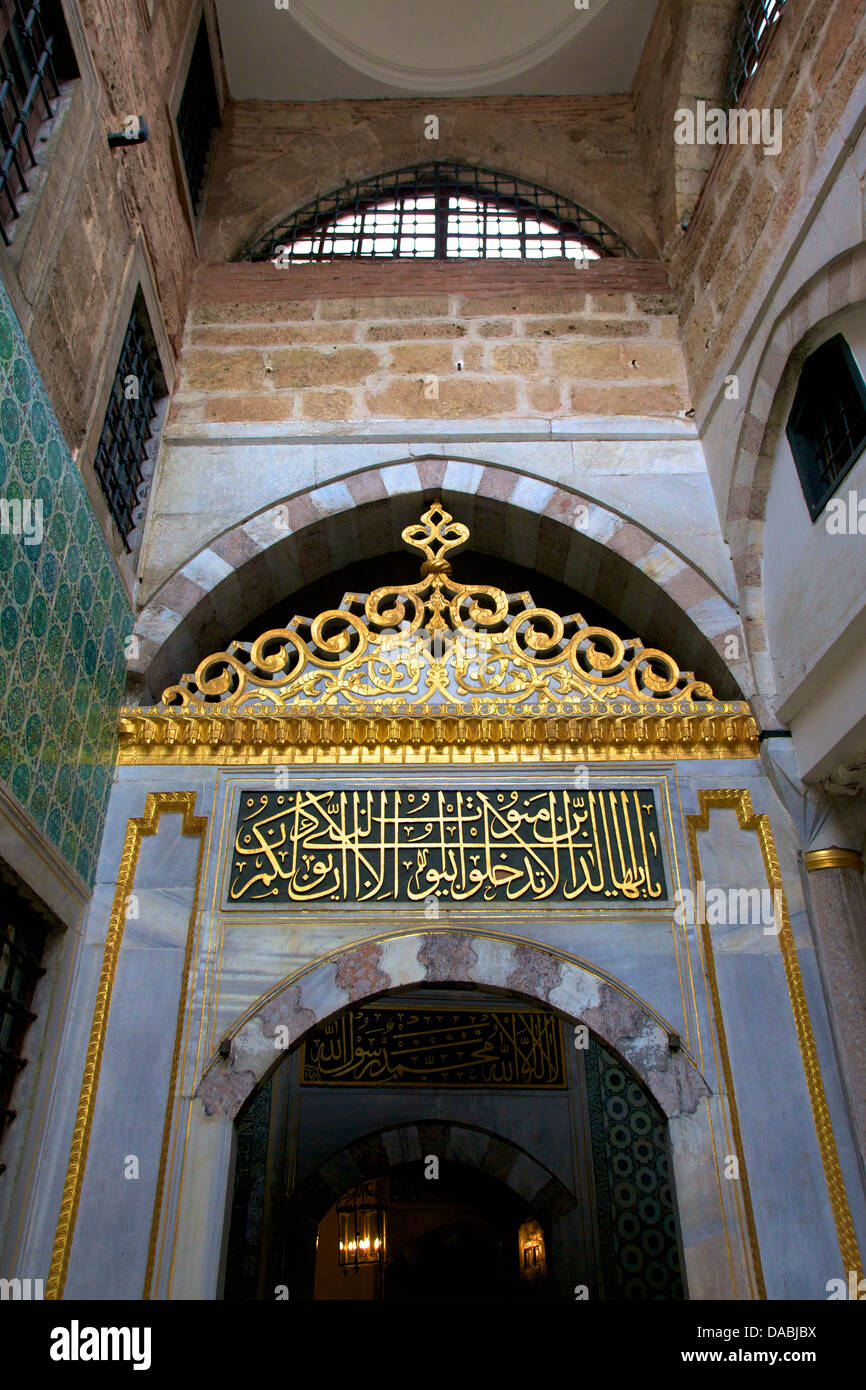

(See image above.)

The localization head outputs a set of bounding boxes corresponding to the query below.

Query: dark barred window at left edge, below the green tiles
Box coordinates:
[0,884,47,1172]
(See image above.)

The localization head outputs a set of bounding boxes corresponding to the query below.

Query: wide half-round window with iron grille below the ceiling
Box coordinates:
[243,163,637,264]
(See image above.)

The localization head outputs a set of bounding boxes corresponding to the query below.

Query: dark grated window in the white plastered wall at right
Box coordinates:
[787,334,866,521]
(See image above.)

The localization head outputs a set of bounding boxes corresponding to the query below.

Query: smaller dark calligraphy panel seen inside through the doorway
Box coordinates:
[300,1006,566,1087]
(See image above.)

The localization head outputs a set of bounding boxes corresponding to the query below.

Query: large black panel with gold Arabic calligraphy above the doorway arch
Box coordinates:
[229,788,667,906]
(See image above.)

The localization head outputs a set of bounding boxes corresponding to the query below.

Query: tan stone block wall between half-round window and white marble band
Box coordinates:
[170,263,688,422]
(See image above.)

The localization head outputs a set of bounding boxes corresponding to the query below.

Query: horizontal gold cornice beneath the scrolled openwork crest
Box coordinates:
[117,706,759,766]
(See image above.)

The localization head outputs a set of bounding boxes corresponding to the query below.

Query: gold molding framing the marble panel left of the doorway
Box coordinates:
[44,791,207,1300]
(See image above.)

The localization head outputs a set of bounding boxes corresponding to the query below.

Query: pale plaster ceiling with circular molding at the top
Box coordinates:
[215,0,656,101]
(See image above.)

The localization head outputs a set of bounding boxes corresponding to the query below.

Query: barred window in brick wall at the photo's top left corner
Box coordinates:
[0,0,78,246]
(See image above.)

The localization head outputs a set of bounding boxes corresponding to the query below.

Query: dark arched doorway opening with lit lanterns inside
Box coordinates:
[224,987,684,1301]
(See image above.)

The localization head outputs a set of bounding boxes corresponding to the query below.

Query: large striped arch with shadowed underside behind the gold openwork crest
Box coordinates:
[129,457,752,703]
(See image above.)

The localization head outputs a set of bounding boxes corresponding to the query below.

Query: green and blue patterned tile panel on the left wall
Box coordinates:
[0,285,132,885]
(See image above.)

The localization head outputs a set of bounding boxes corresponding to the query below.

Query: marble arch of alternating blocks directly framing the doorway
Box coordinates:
[196,929,710,1120]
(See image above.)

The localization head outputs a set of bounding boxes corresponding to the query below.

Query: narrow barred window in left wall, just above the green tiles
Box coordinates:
[93,286,168,552]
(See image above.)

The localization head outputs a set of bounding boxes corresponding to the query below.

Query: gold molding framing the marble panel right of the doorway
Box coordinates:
[685,788,863,1298]
